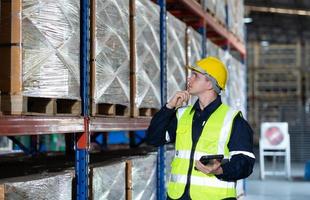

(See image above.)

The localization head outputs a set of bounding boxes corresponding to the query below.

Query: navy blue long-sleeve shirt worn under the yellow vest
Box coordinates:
[147,96,255,200]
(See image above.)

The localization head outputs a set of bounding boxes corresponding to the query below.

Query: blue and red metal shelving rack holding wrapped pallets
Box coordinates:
[0,0,246,200]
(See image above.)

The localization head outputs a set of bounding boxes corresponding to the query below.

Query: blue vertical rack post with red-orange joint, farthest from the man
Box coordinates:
[75,0,90,200]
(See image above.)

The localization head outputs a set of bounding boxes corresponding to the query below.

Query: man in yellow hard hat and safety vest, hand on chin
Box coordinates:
[147,57,255,200]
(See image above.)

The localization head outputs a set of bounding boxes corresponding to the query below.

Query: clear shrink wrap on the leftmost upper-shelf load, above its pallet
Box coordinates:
[21,0,80,99]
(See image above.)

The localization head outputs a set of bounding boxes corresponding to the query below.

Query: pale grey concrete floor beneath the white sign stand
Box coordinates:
[243,163,310,200]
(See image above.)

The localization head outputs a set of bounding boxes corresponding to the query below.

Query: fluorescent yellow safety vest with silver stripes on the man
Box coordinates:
[168,104,239,200]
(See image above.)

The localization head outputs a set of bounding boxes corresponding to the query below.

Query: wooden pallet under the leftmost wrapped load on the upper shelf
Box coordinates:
[1,95,81,116]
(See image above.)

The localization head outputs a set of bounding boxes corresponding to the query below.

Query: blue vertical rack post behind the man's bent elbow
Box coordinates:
[157,0,167,200]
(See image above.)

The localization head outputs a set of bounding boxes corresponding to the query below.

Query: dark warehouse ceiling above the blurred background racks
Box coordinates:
[245,0,310,43]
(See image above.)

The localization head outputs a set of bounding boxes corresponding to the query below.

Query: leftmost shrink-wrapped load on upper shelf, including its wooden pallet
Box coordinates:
[0,0,81,115]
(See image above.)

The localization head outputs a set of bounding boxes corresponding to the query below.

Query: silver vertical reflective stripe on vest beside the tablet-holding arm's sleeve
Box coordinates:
[217,108,237,158]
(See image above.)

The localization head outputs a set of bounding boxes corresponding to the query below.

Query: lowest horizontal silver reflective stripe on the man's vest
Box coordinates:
[170,174,236,189]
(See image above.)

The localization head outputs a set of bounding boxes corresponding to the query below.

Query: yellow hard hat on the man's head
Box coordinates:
[188,56,228,90]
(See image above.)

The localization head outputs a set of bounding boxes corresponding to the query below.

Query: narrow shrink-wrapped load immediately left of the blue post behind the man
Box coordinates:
[136,0,161,108]
